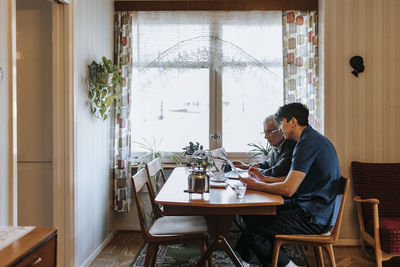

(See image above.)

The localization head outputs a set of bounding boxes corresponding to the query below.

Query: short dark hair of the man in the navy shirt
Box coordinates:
[275,103,309,126]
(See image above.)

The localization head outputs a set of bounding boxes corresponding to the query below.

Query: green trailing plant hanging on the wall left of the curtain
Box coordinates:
[88,57,122,120]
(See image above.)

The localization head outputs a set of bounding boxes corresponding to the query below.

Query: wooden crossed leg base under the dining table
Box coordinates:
[197,215,243,267]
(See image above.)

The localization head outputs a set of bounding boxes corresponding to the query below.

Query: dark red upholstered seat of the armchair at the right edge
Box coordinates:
[365,217,400,254]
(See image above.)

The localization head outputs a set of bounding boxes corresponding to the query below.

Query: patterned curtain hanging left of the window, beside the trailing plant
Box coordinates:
[112,11,132,214]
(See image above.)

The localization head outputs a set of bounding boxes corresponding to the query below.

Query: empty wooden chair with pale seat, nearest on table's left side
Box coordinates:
[131,169,208,267]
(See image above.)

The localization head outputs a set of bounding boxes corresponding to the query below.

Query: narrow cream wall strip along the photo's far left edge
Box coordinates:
[0,0,11,225]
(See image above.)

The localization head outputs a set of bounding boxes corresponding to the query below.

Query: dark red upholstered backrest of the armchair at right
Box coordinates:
[351,161,400,223]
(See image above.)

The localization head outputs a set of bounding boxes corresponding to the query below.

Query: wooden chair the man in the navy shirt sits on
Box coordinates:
[272,177,349,267]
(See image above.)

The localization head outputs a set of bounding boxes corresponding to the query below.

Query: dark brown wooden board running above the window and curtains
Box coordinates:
[114,0,318,11]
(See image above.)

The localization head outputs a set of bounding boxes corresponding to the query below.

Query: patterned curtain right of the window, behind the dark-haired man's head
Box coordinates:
[282,10,323,130]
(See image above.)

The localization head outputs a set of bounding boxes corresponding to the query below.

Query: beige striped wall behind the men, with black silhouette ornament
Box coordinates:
[323,0,400,239]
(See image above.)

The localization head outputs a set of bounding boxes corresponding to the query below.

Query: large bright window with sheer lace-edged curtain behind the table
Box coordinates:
[131,11,283,157]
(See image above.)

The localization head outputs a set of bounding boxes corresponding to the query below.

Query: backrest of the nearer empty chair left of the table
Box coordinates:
[131,169,155,237]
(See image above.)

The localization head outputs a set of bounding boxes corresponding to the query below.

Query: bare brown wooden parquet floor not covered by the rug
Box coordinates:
[90,231,400,267]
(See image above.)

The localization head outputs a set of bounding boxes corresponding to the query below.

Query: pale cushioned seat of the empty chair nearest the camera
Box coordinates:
[149,216,208,236]
